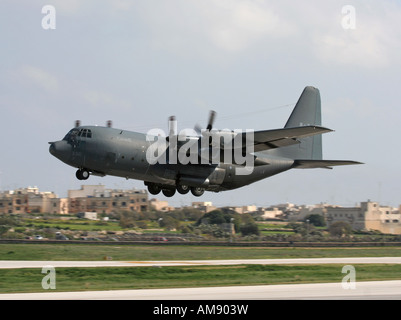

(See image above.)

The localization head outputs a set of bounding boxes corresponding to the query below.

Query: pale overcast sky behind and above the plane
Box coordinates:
[0,0,401,206]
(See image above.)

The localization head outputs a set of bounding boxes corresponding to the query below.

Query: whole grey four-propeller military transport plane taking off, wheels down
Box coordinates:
[49,86,361,197]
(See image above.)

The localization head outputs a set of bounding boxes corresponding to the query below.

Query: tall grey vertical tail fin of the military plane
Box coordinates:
[276,87,322,160]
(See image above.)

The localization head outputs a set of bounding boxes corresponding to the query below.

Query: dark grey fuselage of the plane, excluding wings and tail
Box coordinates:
[50,126,294,192]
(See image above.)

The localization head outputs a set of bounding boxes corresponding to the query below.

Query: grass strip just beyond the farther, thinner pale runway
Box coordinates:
[0,244,401,261]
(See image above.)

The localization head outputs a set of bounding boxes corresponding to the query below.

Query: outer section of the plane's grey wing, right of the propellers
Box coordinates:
[242,126,333,152]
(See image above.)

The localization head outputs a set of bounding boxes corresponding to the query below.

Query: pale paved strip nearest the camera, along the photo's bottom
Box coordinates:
[0,280,401,301]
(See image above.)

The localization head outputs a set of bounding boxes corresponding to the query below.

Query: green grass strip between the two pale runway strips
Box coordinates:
[0,264,401,293]
